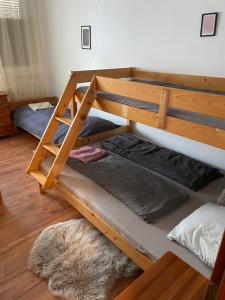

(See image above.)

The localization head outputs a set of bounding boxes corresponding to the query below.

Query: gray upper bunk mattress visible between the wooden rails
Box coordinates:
[77,79,225,130]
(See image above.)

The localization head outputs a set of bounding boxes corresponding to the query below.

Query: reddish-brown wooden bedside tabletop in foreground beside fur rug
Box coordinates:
[115,252,209,300]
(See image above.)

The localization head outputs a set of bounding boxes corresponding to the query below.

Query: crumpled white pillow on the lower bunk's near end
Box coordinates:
[167,203,225,268]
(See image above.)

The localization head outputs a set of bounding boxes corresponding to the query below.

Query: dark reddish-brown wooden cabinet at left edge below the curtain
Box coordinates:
[0,92,16,137]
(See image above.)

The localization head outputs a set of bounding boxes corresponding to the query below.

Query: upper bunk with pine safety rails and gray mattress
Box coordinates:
[71,68,225,149]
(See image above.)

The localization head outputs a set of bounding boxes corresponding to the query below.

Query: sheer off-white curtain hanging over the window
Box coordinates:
[0,0,46,101]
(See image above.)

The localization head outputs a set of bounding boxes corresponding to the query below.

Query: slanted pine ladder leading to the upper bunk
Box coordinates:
[27,74,96,190]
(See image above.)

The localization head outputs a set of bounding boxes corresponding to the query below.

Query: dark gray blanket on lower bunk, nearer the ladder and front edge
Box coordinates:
[67,153,189,223]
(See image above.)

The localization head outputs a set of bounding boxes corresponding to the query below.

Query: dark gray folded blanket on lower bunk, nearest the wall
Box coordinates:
[102,133,223,191]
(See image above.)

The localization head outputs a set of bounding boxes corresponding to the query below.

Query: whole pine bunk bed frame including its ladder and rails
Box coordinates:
[27,68,225,270]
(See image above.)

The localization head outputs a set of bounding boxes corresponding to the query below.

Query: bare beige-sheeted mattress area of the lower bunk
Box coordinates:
[42,158,225,278]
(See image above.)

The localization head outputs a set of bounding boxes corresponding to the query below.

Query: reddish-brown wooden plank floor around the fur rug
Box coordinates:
[0,133,136,300]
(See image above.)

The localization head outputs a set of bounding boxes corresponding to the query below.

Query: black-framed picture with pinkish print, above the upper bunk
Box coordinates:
[200,13,218,37]
